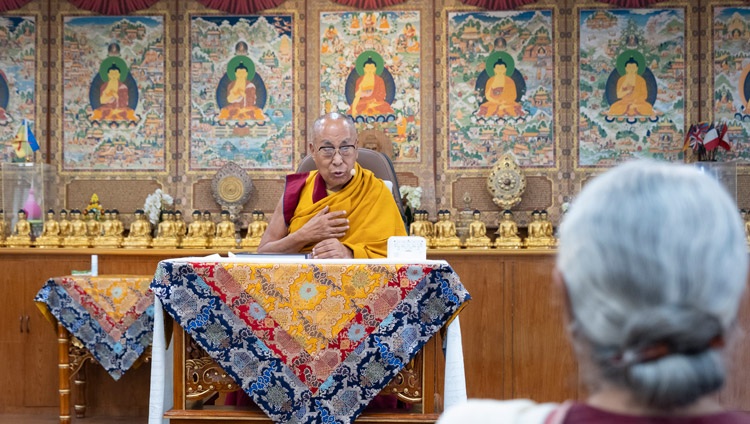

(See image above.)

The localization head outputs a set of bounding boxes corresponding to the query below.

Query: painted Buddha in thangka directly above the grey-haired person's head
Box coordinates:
[602,50,661,123]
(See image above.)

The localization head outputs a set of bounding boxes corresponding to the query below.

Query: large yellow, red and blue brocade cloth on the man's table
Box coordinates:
[151,260,469,423]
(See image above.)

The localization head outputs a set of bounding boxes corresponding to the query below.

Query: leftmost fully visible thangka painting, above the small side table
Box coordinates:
[62,16,166,172]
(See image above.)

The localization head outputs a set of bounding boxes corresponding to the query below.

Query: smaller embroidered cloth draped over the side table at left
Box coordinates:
[34,275,154,380]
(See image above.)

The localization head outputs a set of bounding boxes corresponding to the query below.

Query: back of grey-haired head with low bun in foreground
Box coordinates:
[557,161,748,411]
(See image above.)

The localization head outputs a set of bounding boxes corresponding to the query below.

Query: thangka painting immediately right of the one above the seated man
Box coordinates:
[447,10,555,168]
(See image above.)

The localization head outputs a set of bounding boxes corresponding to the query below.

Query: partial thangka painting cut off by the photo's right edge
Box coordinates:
[711,7,750,159]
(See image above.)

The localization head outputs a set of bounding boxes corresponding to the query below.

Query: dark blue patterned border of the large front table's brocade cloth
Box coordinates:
[151,261,470,423]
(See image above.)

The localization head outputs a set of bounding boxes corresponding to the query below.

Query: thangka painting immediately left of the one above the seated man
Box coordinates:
[189,15,294,170]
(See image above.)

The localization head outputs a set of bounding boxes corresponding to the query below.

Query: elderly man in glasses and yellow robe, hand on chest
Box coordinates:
[258,113,406,259]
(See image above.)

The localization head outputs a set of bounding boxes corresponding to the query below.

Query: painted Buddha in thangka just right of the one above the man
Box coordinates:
[476,51,526,118]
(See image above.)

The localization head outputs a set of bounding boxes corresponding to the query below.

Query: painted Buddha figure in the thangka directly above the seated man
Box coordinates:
[345,50,396,122]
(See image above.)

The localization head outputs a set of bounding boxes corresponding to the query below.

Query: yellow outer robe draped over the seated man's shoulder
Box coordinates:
[289,164,406,258]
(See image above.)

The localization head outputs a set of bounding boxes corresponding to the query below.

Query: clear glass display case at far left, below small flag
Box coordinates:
[0,162,53,237]
